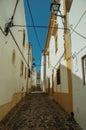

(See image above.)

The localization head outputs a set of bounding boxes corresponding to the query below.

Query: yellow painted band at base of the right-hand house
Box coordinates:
[54,92,72,113]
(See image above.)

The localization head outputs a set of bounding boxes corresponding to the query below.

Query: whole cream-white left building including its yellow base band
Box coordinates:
[0,0,30,120]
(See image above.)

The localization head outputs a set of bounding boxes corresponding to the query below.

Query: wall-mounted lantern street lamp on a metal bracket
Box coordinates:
[50,1,65,18]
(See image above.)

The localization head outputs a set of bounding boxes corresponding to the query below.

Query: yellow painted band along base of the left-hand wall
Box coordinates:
[0,93,25,121]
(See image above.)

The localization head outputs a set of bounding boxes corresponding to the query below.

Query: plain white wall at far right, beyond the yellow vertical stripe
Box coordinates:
[69,0,86,130]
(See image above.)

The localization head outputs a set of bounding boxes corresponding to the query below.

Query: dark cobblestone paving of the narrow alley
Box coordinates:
[0,93,81,130]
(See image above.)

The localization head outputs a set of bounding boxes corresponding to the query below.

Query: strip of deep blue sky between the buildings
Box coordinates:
[24,0,52,71]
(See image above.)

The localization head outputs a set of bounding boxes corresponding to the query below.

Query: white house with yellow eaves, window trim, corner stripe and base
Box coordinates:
[41,0,73,113]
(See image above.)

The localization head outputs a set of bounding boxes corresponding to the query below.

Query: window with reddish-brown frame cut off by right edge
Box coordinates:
[82,55,86,85]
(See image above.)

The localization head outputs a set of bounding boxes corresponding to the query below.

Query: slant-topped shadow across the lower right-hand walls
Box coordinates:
[51,65,86,129]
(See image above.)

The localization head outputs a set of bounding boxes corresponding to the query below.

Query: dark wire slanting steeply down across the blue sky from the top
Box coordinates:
[26,0,42,51]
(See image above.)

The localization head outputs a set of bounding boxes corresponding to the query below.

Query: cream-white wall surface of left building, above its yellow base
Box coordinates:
[0,0,27,105]
